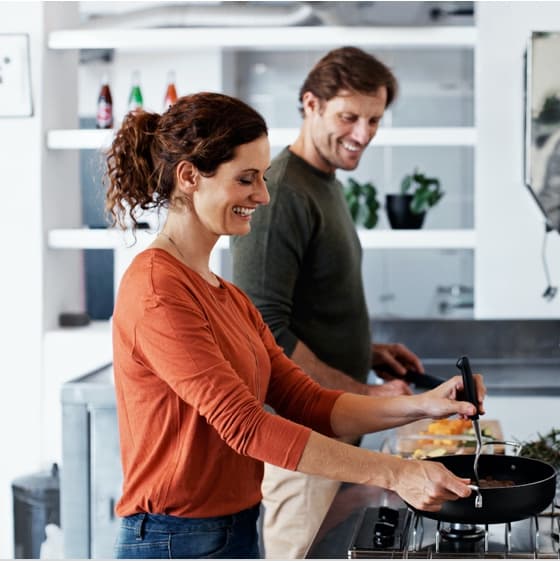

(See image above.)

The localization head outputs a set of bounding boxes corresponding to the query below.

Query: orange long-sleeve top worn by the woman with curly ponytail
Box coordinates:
[113,249,341,517]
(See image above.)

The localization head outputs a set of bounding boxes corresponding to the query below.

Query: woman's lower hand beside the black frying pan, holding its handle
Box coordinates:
[393,460,471,511]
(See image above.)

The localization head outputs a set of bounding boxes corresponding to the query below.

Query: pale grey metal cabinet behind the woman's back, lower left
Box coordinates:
[60,365,122,560]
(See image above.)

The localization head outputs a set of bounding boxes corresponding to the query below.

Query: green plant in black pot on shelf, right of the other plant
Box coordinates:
[385,169,444,229]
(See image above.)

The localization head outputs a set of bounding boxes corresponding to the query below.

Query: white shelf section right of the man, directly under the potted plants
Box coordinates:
[358,229,476,250]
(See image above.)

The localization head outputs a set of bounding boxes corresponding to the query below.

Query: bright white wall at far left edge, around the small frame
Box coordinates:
[0,2,47,558]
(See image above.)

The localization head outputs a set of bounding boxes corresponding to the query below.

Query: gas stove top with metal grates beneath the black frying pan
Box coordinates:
[348,498,560,559]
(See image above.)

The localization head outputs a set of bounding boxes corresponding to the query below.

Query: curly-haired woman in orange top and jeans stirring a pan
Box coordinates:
[107,93,484,558]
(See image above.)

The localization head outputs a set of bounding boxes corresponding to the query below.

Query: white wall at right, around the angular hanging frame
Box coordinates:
[475,1,560,319]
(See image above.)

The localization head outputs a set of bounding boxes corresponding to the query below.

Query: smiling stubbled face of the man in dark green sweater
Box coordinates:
[303,87,387,173]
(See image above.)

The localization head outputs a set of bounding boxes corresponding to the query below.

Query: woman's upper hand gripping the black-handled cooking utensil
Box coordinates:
[417,375,486,419]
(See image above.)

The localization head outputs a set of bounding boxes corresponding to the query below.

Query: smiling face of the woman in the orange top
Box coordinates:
[192,135,270,236]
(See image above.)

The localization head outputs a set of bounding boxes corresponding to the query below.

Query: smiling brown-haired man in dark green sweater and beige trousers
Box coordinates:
[232,47,423,559]
